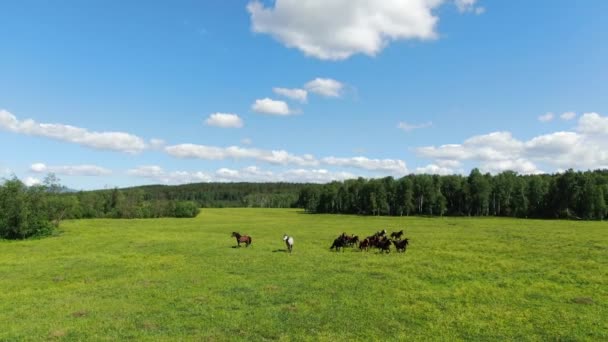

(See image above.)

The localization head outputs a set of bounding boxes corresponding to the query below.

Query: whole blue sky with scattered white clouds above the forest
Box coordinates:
[0,0,608,189]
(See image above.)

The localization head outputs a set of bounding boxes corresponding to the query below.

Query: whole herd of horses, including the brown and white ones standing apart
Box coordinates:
[231,229,410,253]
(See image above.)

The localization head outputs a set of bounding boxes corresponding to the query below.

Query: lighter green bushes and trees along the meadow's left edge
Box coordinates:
[0,174,200,239]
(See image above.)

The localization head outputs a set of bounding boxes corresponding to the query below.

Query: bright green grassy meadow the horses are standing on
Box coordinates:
[0,209,608,341]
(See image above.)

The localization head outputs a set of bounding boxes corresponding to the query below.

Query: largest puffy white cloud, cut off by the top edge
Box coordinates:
[247,0,444,60]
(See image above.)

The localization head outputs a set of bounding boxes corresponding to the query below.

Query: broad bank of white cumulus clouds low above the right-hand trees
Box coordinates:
[415,113,608,174]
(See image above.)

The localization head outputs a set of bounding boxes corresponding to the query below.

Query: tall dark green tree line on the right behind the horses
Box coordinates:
[297,169,608,220]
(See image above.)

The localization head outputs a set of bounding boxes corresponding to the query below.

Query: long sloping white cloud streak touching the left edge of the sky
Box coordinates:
[0,110,146,153]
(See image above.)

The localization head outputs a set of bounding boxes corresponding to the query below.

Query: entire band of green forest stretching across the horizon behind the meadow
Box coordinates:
[0,169,608,238]
